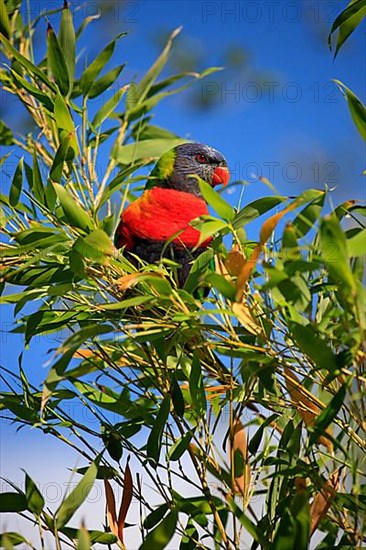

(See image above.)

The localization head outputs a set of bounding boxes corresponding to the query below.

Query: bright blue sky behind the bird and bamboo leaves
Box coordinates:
[0,0,366,548]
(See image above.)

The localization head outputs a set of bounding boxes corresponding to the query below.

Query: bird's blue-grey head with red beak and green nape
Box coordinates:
[147,143,230,197]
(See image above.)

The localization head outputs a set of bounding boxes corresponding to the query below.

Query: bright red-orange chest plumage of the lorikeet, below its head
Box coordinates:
[121,187,211,249]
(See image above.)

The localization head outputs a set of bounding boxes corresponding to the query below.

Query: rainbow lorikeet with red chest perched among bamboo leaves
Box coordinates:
[114,143,230,287]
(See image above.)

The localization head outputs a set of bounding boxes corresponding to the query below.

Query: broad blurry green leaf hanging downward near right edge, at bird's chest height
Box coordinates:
[319,215,355,291]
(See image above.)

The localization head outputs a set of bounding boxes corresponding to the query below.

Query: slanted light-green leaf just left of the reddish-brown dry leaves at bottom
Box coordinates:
[56,459,99,529]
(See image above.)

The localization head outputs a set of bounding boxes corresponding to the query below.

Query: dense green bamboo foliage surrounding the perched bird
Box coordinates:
[0,0,366,550]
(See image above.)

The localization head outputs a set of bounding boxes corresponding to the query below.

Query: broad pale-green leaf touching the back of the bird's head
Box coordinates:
[113,139,187,164]
